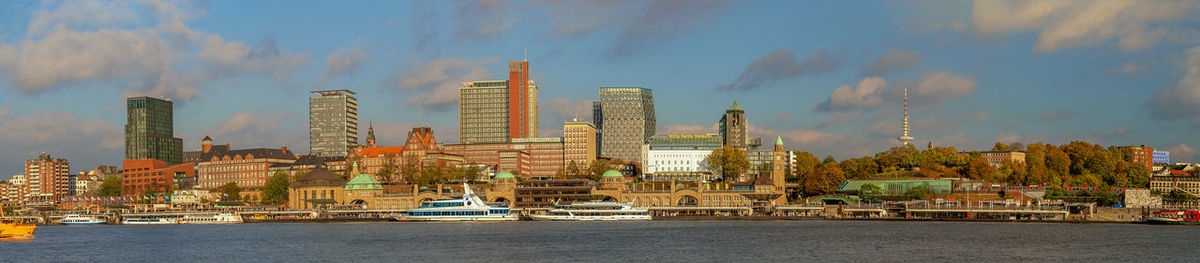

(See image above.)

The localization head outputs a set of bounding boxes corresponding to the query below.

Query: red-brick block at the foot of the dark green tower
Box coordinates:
[121,159,197,196]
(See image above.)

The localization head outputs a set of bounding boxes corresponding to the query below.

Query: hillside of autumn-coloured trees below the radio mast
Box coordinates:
[787,141,1151,195]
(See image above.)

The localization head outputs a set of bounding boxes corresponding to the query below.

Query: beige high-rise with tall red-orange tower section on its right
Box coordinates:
[458,61,538,143]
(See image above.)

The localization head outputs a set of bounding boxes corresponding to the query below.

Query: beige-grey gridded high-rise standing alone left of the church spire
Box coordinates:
[308,90,359,157]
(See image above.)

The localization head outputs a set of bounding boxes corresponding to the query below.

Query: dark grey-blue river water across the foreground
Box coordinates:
[0,221,1200,262]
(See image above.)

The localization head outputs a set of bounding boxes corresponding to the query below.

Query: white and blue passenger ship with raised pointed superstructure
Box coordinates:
[396,183,518,221]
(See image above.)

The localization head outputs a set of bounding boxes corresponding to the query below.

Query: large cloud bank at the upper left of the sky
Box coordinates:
[0,0,307,101]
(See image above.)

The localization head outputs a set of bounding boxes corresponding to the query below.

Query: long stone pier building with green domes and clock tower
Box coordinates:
[289,139,787,210]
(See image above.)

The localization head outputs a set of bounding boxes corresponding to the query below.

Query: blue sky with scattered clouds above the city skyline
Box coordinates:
[0,0,1200,178]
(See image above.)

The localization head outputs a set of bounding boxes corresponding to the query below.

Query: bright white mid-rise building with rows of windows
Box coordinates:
[642,135,724,181]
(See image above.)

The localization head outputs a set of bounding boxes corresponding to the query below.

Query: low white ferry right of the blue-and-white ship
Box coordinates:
[529,202,650,221]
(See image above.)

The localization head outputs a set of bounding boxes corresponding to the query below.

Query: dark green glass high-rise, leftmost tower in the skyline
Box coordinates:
[125,96,184,165]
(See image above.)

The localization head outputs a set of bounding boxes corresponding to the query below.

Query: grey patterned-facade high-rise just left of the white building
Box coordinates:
[592,88,658,163]
